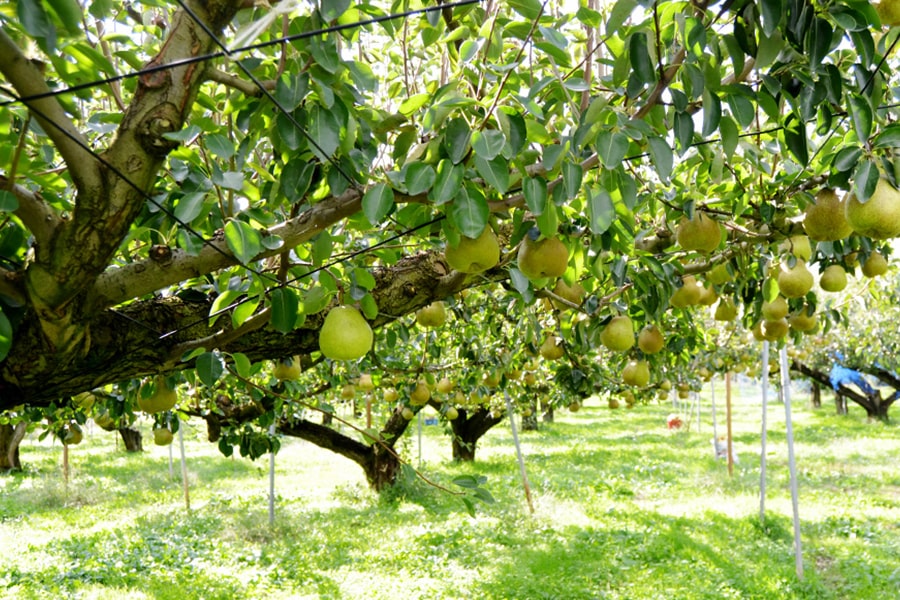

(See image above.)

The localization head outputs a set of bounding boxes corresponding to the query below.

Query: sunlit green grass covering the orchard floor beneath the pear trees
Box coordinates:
[0,382,900,600]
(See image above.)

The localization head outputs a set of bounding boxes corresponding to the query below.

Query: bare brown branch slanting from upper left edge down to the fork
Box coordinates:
[0,30,101,193]
